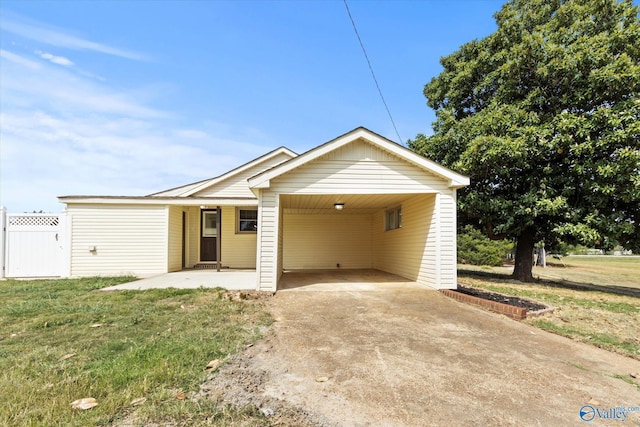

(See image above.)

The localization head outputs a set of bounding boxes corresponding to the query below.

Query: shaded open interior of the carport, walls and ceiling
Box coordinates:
[281,193,436,286]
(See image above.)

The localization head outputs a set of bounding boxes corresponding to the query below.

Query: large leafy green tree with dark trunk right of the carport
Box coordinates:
[409,0,640,281]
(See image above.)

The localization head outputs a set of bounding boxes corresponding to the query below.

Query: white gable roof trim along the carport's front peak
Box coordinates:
[248,126,470,189]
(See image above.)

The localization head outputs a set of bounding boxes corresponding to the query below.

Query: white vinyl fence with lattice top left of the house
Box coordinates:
[0,207,69,278]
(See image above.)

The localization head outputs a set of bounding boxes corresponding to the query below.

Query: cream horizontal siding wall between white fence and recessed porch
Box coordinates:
[67,204,168,277]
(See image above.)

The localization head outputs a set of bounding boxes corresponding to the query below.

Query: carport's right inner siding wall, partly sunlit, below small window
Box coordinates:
[373,194,438,287]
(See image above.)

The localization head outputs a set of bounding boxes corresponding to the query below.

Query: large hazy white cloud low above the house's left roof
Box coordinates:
[0,51,273,212]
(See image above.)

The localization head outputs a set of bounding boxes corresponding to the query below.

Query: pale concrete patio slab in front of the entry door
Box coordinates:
[102,270,256,291]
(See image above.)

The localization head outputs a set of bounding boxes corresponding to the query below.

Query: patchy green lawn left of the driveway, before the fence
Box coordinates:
[0,277,271,426]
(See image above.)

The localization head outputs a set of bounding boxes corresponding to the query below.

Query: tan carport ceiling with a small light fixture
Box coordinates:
[280,194,415,214]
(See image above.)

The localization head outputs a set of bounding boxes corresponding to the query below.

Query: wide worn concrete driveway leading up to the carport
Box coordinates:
[204,273,640,426]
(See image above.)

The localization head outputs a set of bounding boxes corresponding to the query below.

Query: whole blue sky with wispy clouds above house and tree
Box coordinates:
[0,0,502,212]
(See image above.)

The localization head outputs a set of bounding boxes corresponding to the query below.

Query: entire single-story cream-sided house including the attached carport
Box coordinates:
[59,127,469,291]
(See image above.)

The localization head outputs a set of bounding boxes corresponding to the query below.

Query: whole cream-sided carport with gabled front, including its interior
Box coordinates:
[249,128,469,291]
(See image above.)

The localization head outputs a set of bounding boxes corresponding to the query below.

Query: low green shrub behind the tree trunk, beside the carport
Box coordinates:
[458,225,513,265]
